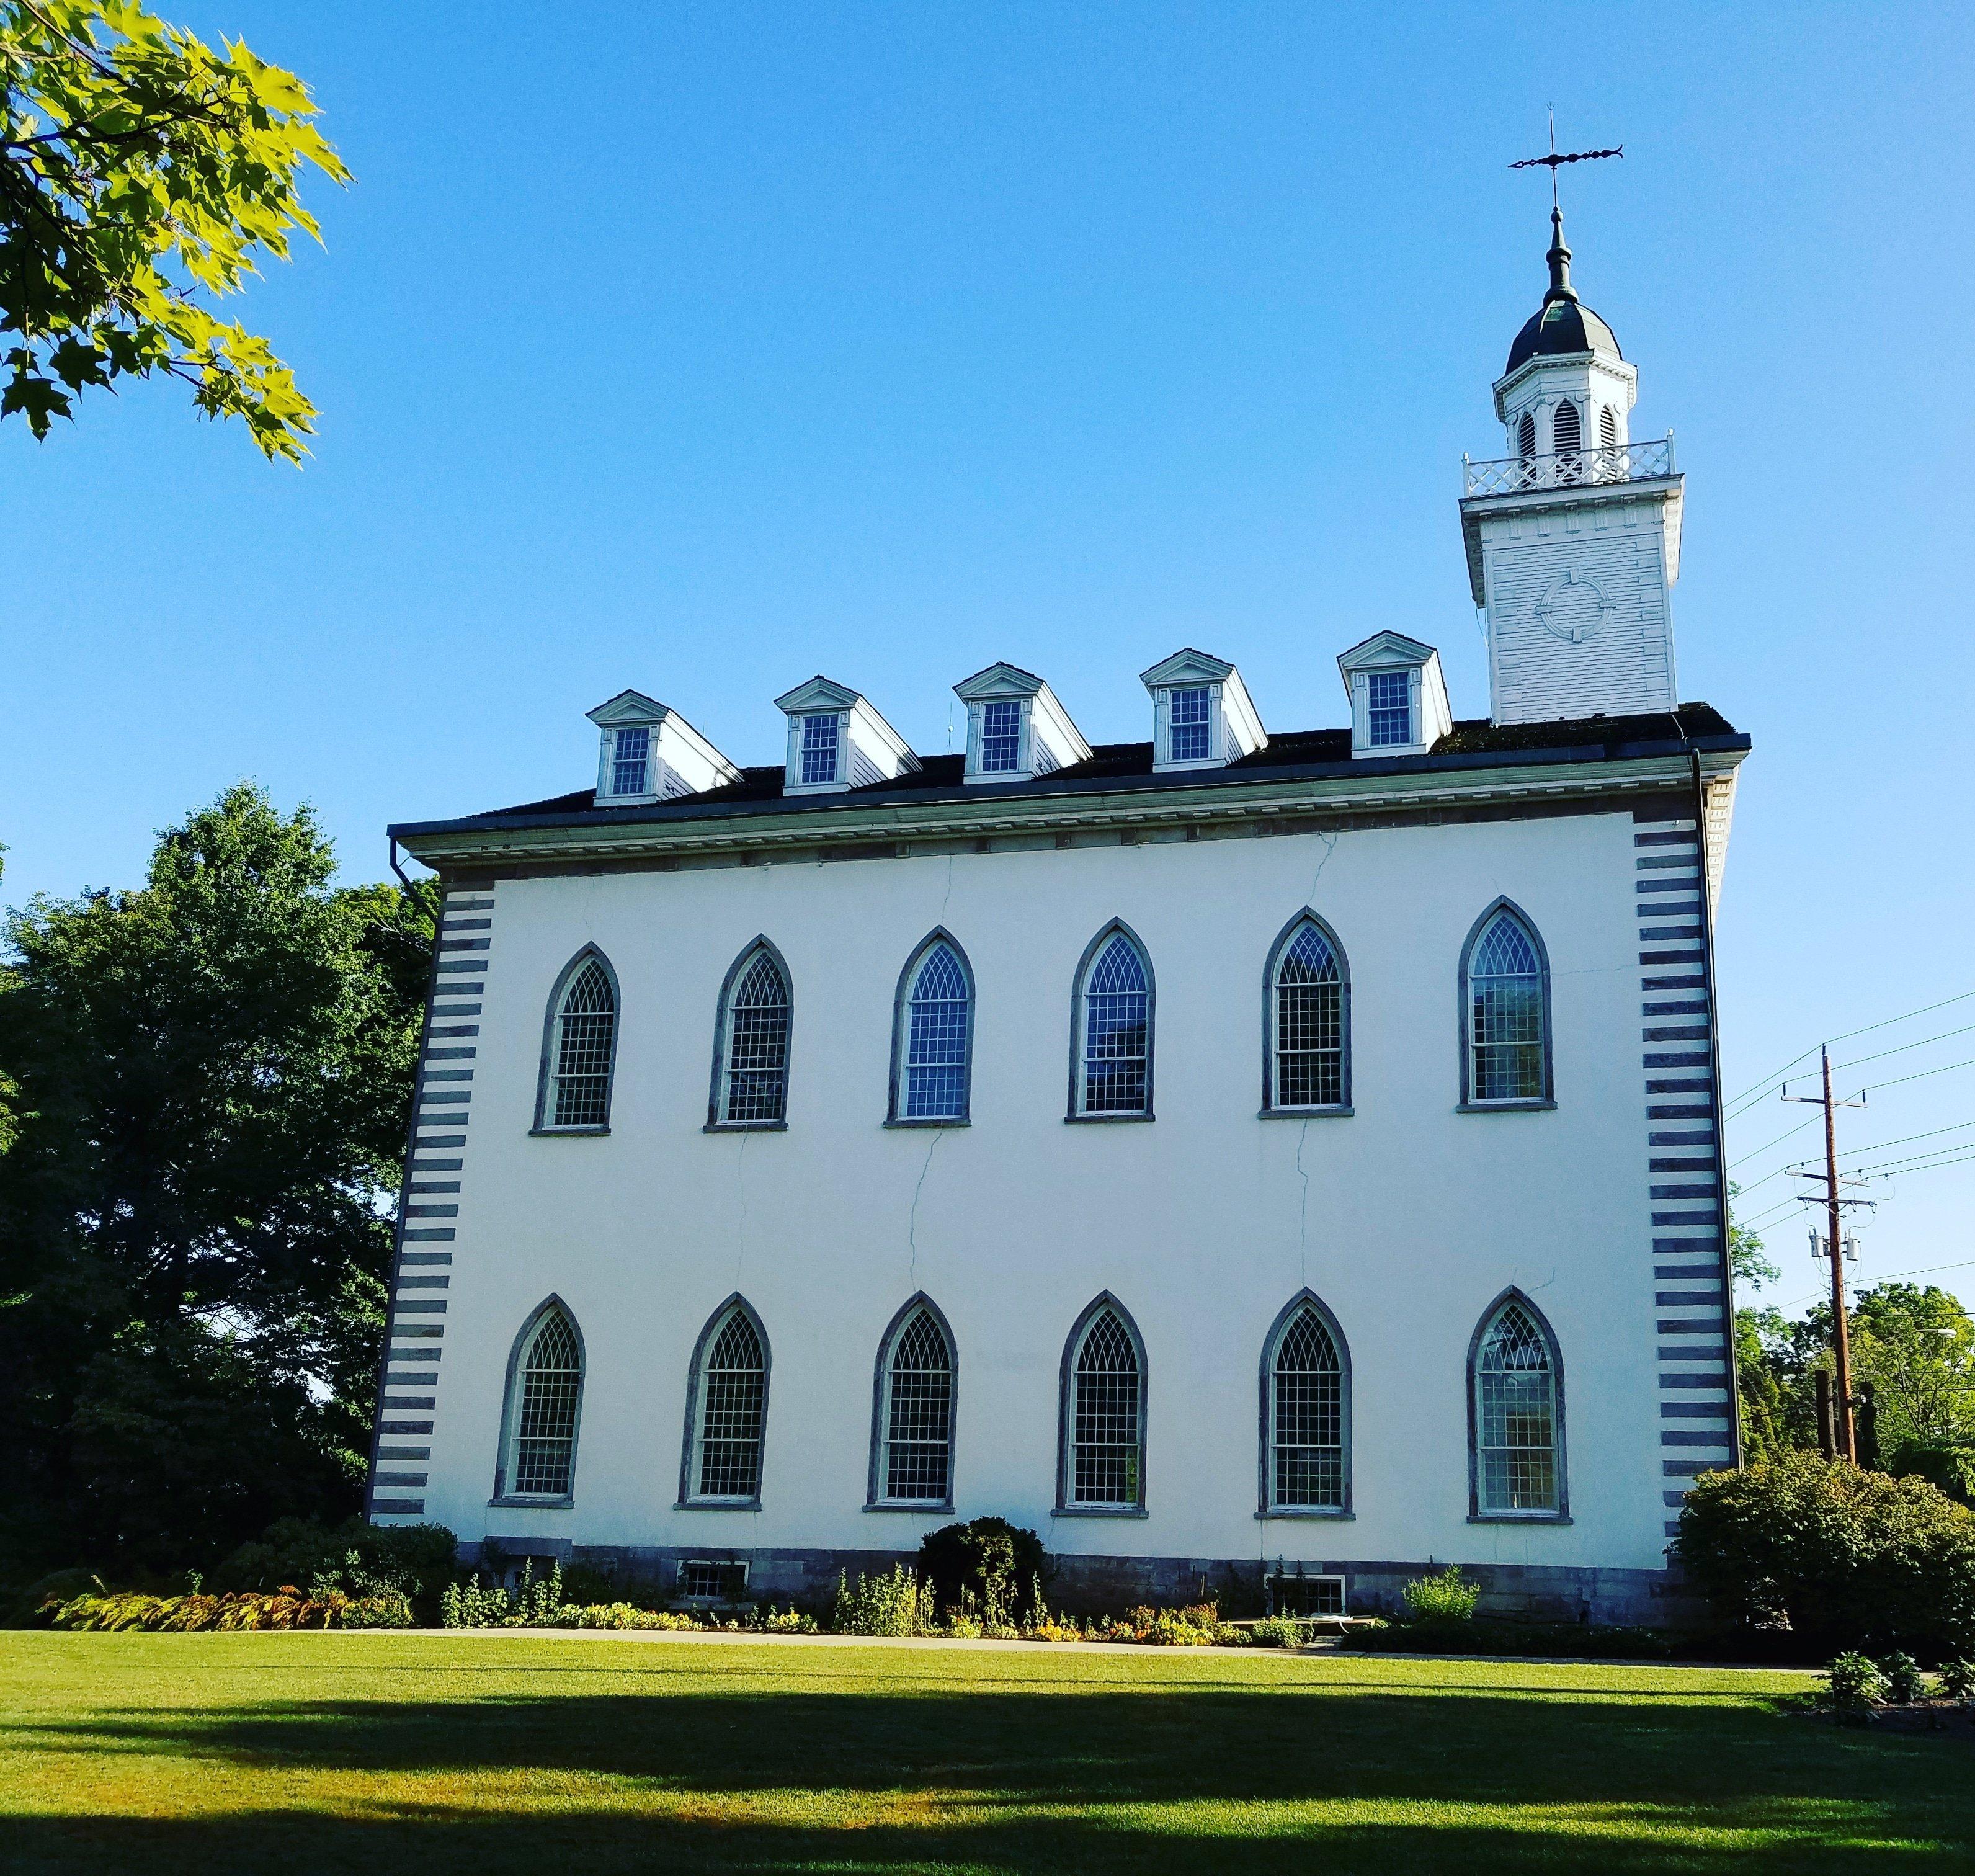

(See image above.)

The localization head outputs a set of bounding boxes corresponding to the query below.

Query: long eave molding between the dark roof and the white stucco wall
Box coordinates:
[397,751,1744,869]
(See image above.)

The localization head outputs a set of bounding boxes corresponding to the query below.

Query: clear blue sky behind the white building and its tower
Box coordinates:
[0,0,1975,1303]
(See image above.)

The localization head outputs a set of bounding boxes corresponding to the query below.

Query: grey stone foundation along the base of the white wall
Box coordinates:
[460,1536,1705,1629]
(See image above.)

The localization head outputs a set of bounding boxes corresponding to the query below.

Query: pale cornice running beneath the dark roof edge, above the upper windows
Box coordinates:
[391,735,1750,869]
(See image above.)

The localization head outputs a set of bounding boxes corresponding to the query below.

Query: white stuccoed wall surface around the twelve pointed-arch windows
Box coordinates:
[409,811,1665,1570]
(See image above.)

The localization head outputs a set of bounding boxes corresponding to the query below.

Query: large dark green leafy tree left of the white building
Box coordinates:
[0,788,432,1564]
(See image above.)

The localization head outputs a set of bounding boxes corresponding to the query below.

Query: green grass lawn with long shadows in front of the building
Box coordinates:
[0,1633,1975,1876]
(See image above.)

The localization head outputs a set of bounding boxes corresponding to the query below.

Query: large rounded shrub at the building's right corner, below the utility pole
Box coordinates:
[1675,1452,1975,1653]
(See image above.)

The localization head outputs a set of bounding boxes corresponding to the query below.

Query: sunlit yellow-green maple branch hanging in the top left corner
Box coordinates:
[0,0,347,460]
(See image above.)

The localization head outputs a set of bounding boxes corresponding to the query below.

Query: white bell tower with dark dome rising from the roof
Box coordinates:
[1461,209,1683,723]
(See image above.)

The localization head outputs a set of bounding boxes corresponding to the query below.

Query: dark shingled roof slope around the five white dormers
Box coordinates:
[466,703,1736,821]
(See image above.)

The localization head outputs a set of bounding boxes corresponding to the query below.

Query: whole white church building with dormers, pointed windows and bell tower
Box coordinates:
[369,217,1750,1621]
